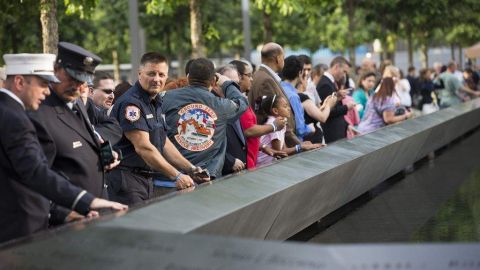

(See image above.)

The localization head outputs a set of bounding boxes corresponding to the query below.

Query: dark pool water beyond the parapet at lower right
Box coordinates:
[290,131,480,243]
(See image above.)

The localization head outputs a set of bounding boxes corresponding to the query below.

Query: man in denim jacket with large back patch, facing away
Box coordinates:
[162,58,248,178]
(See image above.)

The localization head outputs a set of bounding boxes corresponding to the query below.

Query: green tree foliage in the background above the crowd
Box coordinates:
[0,0,480,66]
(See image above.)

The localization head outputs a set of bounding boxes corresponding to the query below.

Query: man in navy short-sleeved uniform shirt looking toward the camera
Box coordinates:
[109,52,209,204]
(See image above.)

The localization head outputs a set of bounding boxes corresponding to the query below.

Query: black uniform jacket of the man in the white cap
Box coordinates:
[0,93,93,242]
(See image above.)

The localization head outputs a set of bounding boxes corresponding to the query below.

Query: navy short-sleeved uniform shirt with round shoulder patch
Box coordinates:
[111,81,167,170]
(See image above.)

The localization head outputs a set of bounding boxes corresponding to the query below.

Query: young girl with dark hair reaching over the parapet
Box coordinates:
[257,95,321,166]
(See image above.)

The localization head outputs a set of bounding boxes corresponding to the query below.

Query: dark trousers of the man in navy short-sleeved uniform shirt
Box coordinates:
[107,169,153,205]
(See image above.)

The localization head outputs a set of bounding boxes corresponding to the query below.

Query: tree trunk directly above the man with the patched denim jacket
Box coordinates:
[189,0,205,58]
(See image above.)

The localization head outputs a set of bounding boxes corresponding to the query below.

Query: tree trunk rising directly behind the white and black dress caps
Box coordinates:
[40,0,58,54]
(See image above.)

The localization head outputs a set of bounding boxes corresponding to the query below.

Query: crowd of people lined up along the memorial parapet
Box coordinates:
[0,42,480,242]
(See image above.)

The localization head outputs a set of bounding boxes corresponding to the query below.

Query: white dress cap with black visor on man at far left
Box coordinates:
[3,53,60,83]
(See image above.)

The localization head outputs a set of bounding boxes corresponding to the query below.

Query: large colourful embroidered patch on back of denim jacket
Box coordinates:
[175,103,217,152]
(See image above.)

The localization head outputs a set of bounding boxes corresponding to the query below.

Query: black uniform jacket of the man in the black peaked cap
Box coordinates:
[29,91,106,197]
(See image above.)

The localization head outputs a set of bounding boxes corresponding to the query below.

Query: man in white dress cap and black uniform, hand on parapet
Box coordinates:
[0,54,126,242]
